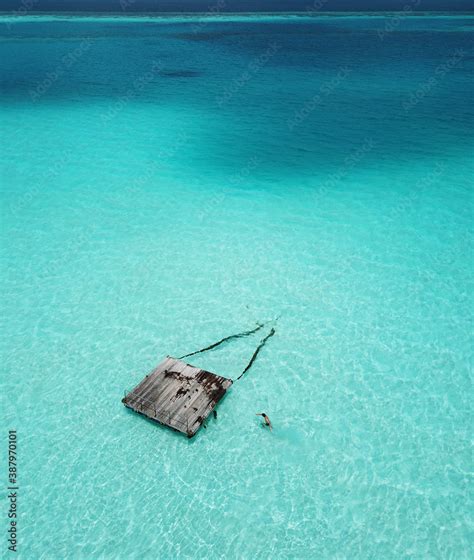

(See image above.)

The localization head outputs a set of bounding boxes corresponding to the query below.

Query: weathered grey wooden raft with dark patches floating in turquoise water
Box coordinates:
[122,356,232,437]
